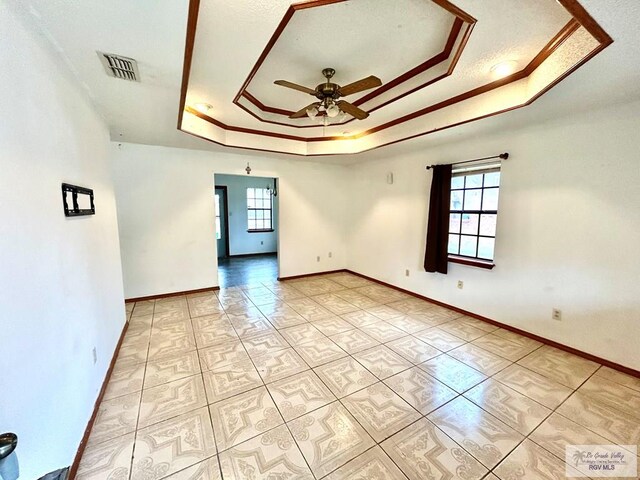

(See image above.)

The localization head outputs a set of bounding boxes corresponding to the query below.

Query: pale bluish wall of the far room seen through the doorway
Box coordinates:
[215,174,278,255]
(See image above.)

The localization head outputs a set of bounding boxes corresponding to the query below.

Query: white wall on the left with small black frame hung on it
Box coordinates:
[0,2,125,479]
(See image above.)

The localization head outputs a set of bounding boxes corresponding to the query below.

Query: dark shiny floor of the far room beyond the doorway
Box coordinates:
[218,253,278,288]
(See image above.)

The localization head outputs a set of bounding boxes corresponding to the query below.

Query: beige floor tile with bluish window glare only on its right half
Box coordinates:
[384,367,458,415]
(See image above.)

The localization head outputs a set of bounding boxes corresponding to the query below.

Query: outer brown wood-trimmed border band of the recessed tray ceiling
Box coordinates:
[178,0,613,156]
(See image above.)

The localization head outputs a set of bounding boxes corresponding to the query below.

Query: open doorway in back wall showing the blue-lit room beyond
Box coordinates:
[214,174,279,288]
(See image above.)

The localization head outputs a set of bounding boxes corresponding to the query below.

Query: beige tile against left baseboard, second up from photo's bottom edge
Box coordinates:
[89,392,142,443]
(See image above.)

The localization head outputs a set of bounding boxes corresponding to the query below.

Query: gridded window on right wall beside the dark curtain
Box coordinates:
[448,165,500,261]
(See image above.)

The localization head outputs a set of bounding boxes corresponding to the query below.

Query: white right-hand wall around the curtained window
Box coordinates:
[347,98,640,369]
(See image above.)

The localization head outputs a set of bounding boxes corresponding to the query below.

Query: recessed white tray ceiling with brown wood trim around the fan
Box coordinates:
[178,0,611,155]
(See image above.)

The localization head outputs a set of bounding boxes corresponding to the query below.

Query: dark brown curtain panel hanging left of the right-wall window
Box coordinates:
[424,165,452,274]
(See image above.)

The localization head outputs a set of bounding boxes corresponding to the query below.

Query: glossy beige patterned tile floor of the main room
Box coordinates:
[77,273,640,480]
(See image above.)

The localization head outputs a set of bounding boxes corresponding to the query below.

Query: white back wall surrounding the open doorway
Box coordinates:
[112,143,347,298]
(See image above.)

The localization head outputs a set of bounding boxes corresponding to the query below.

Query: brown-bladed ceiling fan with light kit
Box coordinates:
[273,68,382,120]
